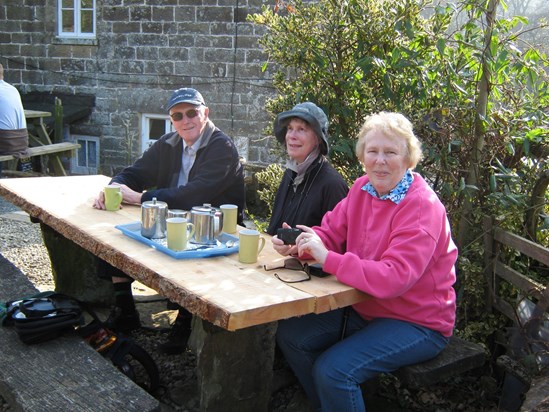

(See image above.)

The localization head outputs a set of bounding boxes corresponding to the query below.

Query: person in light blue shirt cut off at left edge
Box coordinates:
[0,64,29,173]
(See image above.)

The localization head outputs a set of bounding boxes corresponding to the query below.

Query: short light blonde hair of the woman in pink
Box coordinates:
[355,112,423,169]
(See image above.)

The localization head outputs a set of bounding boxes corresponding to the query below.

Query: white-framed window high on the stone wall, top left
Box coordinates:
[57,0,96,39]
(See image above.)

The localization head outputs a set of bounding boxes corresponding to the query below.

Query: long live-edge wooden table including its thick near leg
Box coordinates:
[0,175,366,412]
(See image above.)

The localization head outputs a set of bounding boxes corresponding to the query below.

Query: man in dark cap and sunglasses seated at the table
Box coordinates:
[93,88,245,353]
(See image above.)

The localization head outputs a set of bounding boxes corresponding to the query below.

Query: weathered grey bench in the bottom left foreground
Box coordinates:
[0,255,160,412]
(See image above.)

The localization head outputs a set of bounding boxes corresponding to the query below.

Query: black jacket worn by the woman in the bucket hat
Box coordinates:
[267,155,349,235]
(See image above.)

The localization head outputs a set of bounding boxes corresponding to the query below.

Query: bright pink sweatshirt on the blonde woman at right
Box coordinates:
[313,173,457,337]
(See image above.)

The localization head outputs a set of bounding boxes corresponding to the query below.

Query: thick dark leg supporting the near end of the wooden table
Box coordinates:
[191,316,277,412]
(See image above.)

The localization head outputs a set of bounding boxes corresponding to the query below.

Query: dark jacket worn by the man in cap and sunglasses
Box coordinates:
[112,128,245,223]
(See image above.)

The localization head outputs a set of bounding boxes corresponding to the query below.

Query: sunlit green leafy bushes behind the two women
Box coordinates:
[249,0,549,329]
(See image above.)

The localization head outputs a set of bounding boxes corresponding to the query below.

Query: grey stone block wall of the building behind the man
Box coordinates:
[0,0,274,174]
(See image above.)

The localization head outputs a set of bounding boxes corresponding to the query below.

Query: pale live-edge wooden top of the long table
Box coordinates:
[0,175,366,330]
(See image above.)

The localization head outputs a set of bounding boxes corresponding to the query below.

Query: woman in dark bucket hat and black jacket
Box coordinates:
[267,102,349,240]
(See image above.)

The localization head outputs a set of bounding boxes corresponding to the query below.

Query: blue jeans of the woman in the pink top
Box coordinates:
[276,308,448,412]
